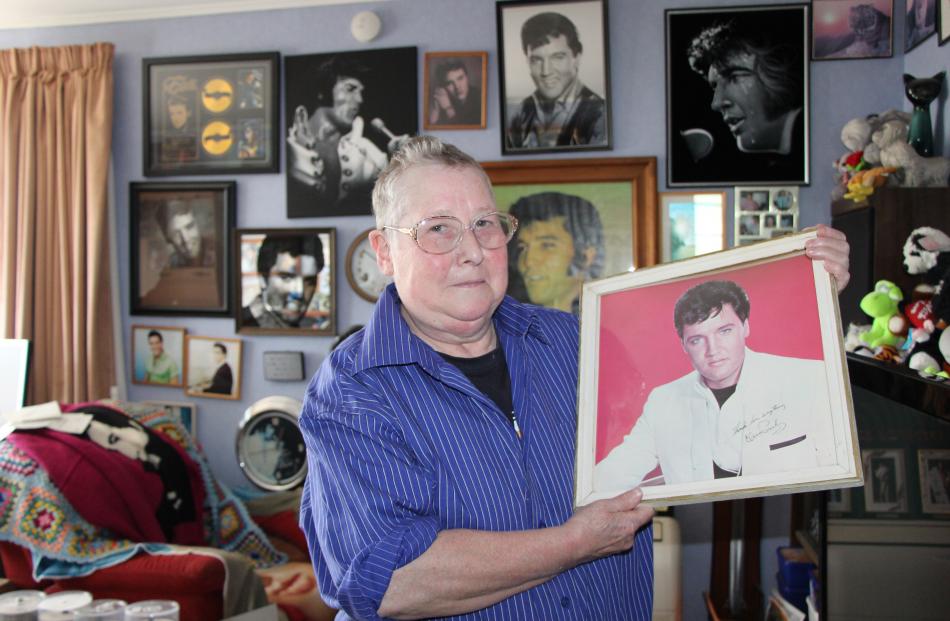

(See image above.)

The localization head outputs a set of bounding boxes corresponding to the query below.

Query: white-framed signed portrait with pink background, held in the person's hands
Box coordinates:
[575,231,863,505]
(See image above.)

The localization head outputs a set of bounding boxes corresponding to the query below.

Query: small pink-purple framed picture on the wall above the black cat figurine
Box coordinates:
[811,0,894,60]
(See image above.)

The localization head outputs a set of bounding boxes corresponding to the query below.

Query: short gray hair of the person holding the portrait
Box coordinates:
[373,136,491,229]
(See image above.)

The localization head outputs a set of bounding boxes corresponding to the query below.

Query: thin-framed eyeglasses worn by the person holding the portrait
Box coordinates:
[383,211,518,254]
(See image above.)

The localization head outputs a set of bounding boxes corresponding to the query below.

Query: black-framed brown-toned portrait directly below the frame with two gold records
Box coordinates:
[129,181,237,317]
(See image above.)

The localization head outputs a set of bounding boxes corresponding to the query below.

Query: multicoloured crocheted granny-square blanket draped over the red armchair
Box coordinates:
[0,401,287,580]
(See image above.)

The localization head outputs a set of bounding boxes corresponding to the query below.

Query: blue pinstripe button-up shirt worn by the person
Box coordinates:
[300,285,653,620]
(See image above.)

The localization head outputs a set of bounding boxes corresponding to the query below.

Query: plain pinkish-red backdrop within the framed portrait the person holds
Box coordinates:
[595,255,823,461]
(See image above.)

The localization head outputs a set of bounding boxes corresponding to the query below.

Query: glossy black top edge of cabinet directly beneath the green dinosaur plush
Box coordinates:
[848,354,950,421]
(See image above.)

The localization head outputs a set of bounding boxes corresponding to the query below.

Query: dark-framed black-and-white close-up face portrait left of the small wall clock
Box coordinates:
[234,228,336,336]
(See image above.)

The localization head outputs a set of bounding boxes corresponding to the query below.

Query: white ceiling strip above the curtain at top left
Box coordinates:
[0,0,374,29]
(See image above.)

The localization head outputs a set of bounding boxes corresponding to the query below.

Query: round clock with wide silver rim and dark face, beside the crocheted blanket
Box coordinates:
[237,397,307,492]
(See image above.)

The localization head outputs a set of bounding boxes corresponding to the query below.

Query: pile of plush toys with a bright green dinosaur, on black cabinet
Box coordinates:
[845,226,950,381]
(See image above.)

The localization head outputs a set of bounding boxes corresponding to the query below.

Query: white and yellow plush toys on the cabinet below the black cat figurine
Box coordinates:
[831,110,950,201]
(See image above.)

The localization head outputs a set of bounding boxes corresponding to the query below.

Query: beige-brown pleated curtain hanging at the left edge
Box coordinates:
[0,43,115,403]
